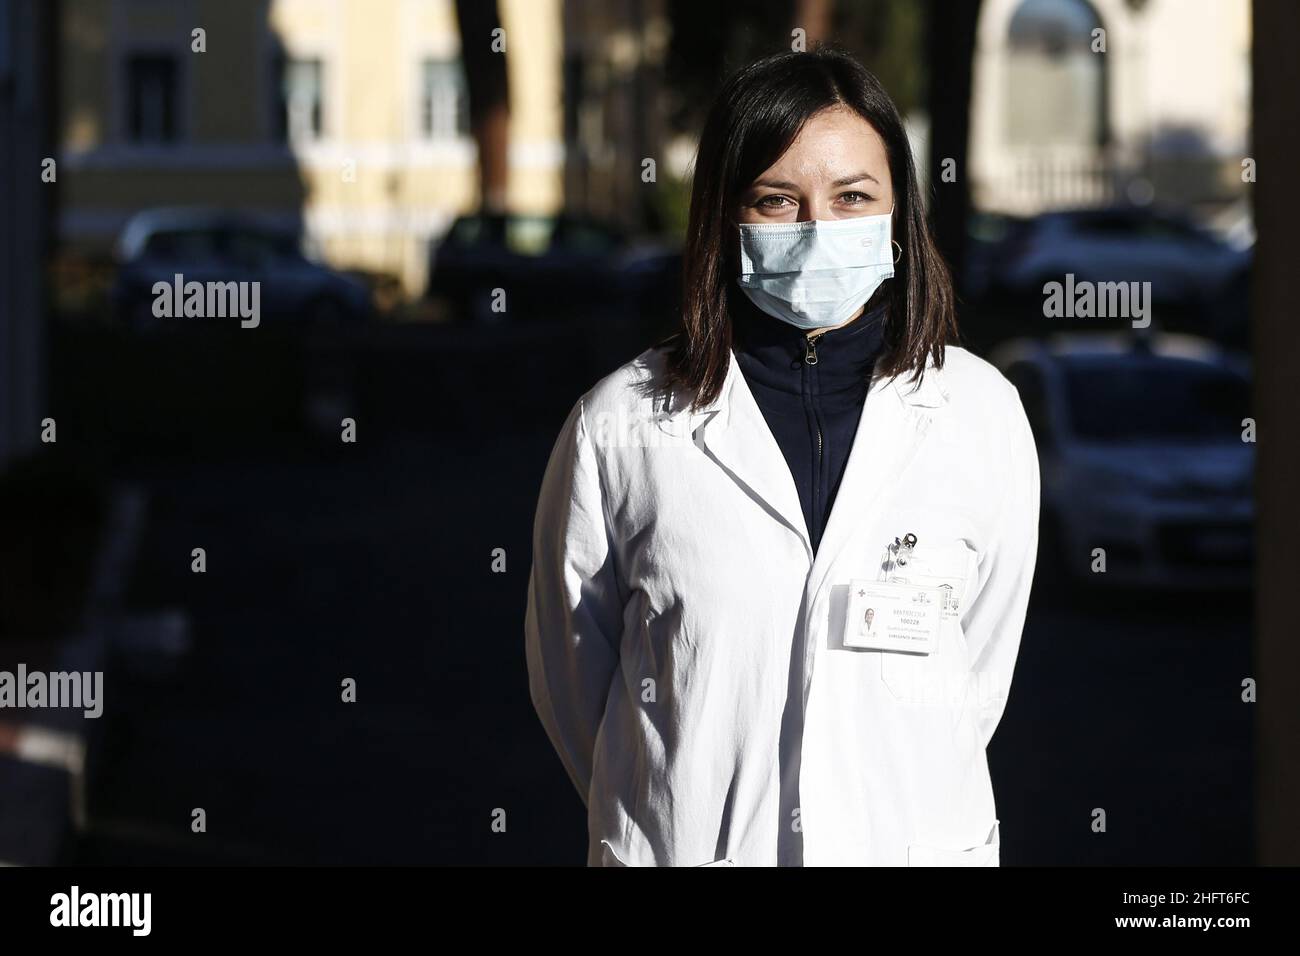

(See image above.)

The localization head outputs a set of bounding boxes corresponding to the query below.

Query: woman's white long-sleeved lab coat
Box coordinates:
[525,347,1039,866]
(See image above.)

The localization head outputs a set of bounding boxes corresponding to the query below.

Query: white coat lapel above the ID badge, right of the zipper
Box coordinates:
[809,364,948,596]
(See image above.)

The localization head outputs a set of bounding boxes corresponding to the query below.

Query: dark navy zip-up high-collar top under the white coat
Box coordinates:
[733,297,887,553]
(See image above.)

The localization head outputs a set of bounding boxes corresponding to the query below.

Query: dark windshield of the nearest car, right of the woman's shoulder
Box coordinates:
[1065,358,1249,442]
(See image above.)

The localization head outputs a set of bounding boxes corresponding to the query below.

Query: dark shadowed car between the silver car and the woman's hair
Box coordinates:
[429,213,681,323]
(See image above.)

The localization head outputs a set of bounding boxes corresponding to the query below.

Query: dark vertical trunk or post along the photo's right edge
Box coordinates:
[1248,0,1300,866]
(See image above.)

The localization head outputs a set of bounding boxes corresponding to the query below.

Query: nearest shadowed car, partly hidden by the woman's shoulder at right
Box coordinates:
[993,334,1255,589]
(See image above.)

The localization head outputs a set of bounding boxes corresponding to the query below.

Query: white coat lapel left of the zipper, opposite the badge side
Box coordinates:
[693,355,813,555]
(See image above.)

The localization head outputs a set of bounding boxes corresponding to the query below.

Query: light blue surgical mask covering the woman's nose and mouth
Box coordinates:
[737,208,894,329]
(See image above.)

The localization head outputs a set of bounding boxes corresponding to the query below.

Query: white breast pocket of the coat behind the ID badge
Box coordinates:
[880,540,976,704]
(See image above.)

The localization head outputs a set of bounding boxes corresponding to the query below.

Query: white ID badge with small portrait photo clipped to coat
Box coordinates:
[844,579,945,654]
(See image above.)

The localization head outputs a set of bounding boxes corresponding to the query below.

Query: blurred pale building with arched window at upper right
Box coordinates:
[970,0,1251,213]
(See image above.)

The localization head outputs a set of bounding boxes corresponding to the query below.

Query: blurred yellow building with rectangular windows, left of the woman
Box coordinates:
[59,0,563,295]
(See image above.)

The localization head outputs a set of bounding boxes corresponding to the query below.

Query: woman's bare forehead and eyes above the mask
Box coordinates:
[736,107,893,222]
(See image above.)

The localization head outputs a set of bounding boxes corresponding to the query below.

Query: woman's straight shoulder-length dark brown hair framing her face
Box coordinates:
[663,48,957,407]
